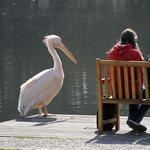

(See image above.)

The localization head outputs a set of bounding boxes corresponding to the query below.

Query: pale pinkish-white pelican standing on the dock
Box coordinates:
[18,35,77,117]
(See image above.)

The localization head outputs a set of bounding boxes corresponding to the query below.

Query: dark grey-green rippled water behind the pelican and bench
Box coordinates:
[0,0,150,121]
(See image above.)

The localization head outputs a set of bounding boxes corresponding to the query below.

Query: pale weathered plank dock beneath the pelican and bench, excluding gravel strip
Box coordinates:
[0,114,150,140]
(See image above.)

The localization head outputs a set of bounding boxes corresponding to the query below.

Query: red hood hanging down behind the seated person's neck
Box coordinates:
[114,44,132,55]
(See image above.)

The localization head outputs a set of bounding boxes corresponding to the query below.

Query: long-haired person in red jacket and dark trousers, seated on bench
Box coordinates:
[107,29,150,132]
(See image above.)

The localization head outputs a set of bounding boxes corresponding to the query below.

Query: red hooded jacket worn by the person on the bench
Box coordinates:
[108,44,144,97]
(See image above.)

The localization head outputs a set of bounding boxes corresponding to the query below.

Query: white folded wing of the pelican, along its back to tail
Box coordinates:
[18,69,55,114]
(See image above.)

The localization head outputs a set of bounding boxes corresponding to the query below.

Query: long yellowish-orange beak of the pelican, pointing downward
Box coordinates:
[56,42,77,64]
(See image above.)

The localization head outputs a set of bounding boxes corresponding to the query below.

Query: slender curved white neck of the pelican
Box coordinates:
[48,44,63,71]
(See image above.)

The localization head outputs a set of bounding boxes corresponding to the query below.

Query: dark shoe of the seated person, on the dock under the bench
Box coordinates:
[127,119,147,132]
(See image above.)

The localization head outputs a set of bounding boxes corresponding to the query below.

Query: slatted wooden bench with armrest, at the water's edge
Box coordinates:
[96,58,150,133]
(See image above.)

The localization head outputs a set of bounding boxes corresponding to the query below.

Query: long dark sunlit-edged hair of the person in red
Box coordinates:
[107,28,144,59]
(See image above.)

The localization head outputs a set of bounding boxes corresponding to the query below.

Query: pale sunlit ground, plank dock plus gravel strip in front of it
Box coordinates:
[0,114,150,150]
